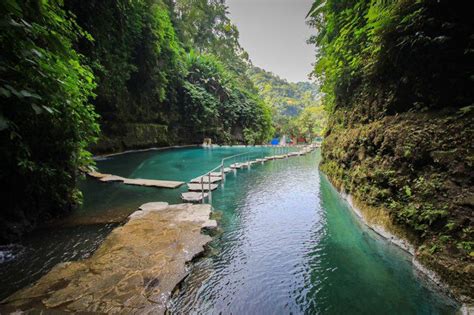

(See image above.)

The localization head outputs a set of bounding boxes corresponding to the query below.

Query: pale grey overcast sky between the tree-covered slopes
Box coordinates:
[226,0,315,82]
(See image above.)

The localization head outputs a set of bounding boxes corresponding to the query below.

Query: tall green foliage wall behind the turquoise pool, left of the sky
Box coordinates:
[68,0,268,147]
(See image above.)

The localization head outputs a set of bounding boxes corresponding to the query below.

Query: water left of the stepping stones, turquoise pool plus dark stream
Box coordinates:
[0,147,288,300]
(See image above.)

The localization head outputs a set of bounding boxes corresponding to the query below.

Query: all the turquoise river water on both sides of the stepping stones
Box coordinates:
[0,148,457,314]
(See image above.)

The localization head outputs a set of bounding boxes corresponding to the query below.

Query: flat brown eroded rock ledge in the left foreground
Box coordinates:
[0,202,217,314]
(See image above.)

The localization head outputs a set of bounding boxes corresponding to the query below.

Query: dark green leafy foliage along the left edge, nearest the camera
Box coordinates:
[0,0,99,239]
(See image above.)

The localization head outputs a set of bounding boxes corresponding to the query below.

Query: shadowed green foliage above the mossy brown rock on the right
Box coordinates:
[308,0,473,116]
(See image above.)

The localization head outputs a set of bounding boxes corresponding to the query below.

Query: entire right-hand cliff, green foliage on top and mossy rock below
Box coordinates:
[309,0,474,297]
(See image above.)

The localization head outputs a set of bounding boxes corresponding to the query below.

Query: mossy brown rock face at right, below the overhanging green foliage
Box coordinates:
[321,107,474,302]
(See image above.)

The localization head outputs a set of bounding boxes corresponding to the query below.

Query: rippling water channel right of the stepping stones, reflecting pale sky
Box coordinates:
[170,153,454,314]
